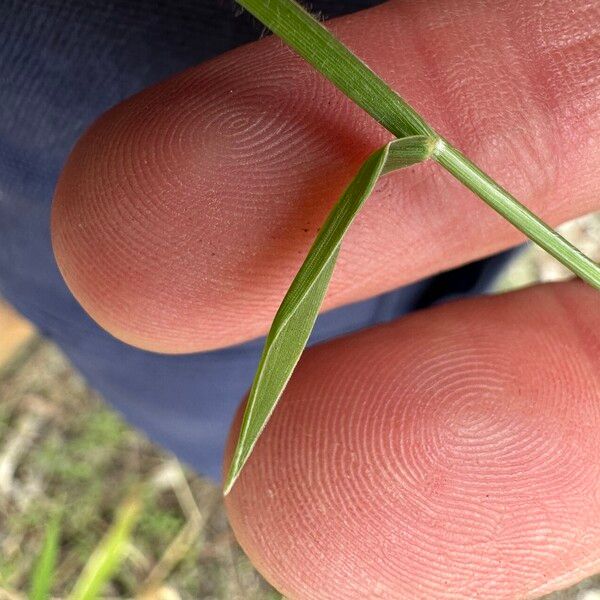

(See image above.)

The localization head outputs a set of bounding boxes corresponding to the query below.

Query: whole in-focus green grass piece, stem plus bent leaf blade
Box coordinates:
[224,0,600,494]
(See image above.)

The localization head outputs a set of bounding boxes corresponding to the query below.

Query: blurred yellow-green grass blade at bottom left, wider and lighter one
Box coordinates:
[69,495,141,600]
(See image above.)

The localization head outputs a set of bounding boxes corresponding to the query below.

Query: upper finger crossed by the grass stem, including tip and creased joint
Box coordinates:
[52,0,600,352]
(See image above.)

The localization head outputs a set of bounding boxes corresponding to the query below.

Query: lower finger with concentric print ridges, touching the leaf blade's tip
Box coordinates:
[225,283,600,600]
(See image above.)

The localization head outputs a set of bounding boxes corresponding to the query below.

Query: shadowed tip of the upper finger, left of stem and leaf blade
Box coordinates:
[51,34,386,353]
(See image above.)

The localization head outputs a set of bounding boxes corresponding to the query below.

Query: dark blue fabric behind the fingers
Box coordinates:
[0,0,516,479]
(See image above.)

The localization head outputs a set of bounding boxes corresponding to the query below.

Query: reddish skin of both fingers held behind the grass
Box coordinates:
[52,0,600,599]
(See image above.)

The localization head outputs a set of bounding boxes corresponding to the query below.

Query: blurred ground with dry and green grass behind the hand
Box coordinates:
[0,215,600,600]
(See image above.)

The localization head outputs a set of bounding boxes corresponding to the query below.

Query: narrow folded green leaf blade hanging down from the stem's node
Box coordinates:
[224,136,435,494]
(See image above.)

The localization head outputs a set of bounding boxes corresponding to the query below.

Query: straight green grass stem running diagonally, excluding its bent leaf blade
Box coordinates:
[237,0,600,289]
